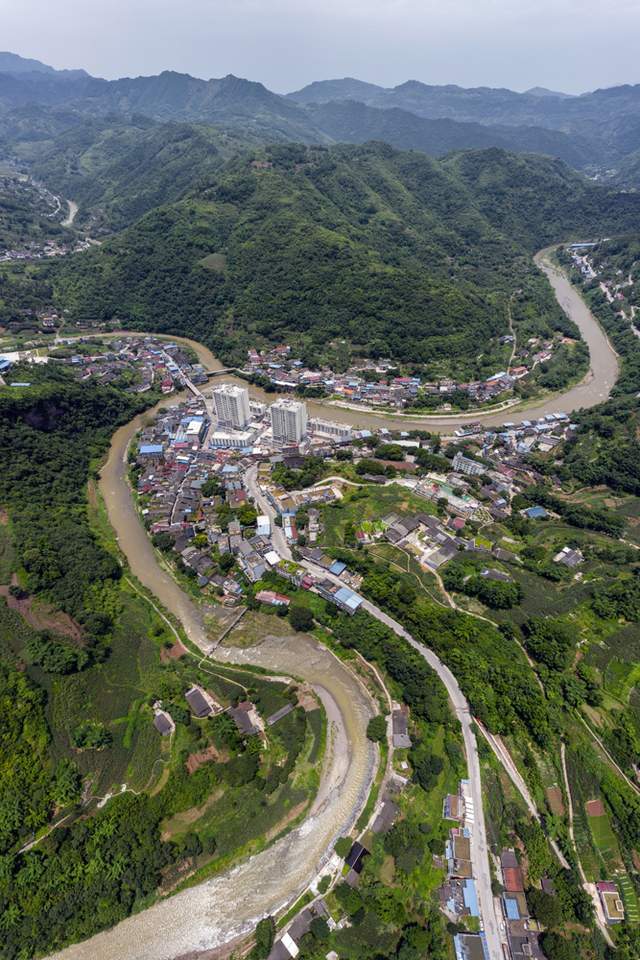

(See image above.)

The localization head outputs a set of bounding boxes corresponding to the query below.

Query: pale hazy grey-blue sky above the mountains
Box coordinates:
[0,0,640,92]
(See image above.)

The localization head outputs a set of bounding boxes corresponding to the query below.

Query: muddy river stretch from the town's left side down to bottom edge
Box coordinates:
[53,406,378,960]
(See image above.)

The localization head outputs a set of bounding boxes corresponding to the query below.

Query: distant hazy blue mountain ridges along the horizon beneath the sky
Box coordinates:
[0,53,640,172]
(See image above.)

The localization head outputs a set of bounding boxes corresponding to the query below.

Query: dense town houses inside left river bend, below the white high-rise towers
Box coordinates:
[136,398,372,613]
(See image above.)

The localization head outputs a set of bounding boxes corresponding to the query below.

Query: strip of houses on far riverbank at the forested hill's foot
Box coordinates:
[242,334,555,409]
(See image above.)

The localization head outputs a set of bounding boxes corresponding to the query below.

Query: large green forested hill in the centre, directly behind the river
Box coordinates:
[22,143,640,373]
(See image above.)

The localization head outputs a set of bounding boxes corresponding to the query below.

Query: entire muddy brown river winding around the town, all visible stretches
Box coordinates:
[47,251,618,960]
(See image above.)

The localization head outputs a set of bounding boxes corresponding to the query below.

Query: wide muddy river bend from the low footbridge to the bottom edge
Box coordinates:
[54,635,377,960]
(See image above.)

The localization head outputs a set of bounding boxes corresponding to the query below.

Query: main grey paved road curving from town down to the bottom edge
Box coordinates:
[303,561,503,960]
